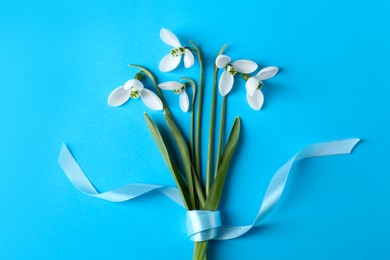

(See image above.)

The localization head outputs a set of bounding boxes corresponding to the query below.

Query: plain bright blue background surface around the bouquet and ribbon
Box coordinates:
[0,0,390,259]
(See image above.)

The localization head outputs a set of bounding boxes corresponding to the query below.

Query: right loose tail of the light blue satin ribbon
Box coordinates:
[214,138,360,240]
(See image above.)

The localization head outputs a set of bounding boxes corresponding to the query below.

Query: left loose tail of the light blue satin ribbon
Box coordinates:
[58,144,184,207]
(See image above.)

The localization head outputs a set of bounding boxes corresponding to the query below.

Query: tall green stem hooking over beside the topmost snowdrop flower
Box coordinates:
[190,41,204,181]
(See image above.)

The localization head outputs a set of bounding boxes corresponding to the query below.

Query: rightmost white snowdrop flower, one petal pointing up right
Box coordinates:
[245,66,279,110]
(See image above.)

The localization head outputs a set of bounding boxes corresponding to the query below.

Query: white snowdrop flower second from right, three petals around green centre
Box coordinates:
[215,55,257,96]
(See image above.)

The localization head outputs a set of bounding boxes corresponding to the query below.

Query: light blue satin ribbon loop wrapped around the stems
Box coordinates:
[187,210,221,242]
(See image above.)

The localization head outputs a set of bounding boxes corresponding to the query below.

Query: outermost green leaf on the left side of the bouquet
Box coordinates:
[144,113,189,210]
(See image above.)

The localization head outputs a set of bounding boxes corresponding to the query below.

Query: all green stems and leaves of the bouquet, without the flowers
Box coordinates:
[137,41,240,260]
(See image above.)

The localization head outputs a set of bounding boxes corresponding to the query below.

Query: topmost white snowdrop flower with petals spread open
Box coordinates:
[159,28,194,72]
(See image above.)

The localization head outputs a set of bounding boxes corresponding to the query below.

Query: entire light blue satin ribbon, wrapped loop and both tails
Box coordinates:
[58,138,360,241]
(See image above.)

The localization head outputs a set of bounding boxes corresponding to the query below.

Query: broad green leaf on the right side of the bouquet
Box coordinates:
[204,117,241,210]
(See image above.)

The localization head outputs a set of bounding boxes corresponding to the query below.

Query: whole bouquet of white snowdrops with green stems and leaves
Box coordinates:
[108,29,278,260]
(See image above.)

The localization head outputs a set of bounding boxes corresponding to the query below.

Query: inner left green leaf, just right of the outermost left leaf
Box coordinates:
[164,113,195,209]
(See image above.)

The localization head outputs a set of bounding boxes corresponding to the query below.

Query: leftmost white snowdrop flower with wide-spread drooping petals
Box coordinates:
[108,79,163,110]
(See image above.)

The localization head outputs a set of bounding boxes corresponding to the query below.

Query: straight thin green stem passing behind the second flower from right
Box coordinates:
[206,44,227,197]
